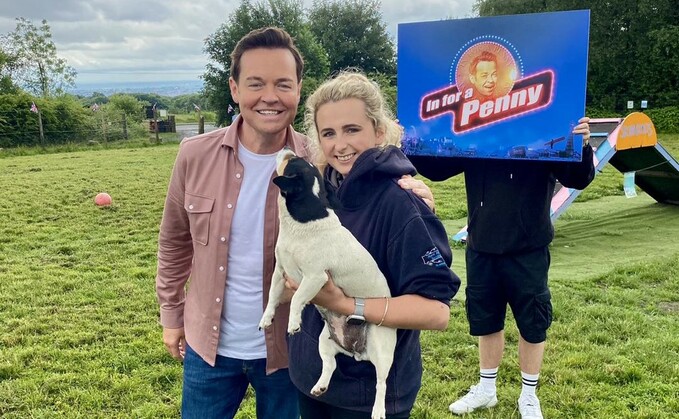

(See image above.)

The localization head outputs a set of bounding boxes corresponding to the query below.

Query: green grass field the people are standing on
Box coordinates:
[0,136,679,419]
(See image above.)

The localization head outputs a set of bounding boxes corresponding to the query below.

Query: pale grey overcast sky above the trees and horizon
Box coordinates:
[0,0,474,84]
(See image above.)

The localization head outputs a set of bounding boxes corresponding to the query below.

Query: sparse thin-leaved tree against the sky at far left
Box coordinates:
[0,17,76,97]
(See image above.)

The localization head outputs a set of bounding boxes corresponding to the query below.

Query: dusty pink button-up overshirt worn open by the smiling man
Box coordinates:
[156,118,308,373]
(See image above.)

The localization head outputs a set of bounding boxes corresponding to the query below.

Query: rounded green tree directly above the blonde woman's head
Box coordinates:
[309,0,396,75]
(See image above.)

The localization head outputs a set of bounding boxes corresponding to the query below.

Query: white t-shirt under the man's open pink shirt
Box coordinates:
[217,142,277,359]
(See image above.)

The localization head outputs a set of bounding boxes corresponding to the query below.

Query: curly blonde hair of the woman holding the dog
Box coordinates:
[304,70,403,171]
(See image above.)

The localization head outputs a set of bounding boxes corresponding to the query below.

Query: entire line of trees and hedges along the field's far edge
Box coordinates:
[0,0,679,147]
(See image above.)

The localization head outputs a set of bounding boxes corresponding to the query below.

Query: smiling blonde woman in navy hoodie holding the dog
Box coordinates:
[288,72,460,419]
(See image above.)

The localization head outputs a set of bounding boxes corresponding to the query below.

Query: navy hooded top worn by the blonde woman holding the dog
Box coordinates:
[288,147,460,414]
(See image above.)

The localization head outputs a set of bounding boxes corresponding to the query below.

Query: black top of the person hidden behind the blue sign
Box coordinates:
[410,145,594,254]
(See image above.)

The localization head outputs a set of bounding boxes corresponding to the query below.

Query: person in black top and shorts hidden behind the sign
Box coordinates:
[409,117,594,419]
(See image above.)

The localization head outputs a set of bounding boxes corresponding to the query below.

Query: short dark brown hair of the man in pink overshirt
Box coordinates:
[231,27,304,82]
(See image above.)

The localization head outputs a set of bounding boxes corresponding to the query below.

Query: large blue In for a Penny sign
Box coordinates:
[398,10,589,161]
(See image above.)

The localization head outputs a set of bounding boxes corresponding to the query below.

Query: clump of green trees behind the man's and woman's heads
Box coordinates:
[203,0,396,125]
